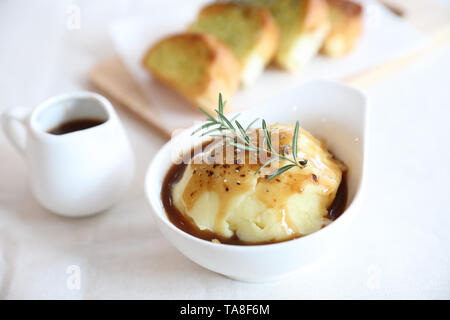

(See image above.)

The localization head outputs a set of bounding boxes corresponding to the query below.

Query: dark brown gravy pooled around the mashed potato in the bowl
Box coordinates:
[161,141,348,245]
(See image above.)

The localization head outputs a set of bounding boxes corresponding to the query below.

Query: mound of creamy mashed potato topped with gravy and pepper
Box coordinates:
[172,124,345,243]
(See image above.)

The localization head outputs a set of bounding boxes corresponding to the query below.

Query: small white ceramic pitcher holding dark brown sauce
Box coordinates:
[2,92,135,217]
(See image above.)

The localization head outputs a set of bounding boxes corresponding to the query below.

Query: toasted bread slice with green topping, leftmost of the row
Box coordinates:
[143,32,240,112]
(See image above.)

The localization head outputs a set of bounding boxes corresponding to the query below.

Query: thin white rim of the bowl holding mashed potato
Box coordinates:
[144,80,369,251]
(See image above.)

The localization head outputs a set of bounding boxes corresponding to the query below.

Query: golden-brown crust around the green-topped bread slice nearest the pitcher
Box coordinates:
[142,32,240,112]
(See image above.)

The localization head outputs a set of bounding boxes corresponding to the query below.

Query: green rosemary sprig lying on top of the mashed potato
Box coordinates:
[192,93,308,180]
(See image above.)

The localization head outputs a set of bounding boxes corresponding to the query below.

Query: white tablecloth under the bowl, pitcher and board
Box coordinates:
[0,0,450,299]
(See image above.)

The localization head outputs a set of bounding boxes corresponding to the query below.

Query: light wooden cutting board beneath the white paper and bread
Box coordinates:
[89,0,450,138]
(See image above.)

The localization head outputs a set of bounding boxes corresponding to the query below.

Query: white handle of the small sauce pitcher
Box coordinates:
[1,107,30,156]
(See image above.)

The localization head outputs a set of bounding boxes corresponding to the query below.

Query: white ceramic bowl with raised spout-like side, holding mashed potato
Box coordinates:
[145,81,367,282]
